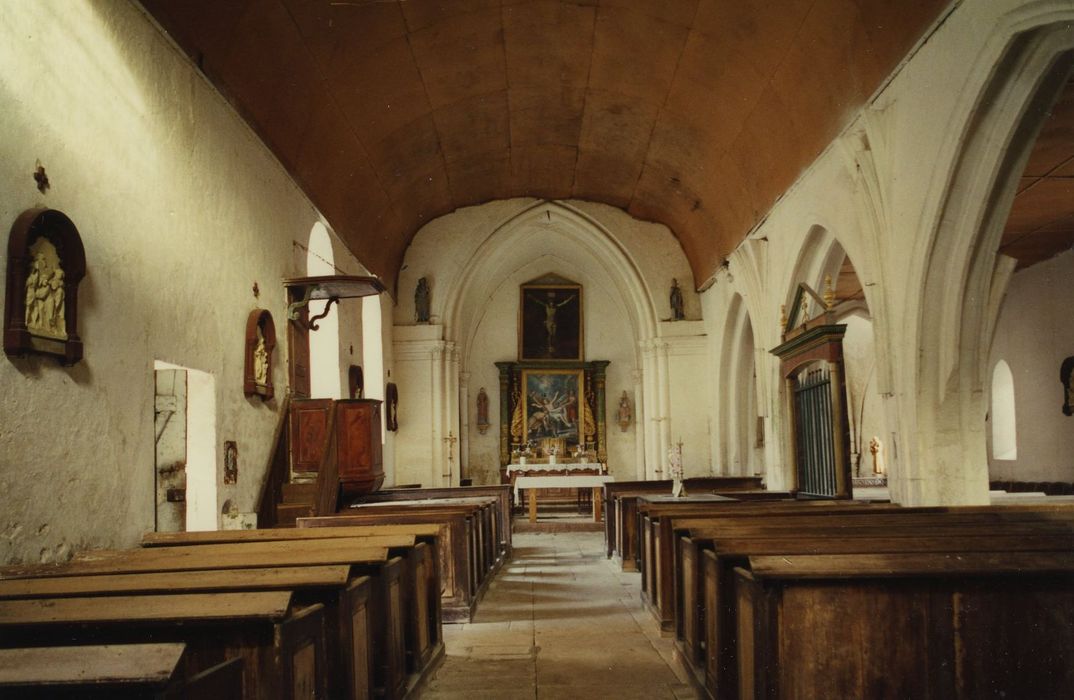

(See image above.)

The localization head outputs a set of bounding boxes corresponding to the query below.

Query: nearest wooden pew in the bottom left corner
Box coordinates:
[0,643,243,700]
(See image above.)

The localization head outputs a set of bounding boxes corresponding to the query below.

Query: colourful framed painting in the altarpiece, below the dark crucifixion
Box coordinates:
[522,369,585,447]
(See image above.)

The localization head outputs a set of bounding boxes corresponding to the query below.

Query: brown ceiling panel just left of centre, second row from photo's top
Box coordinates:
[433,90,510,163]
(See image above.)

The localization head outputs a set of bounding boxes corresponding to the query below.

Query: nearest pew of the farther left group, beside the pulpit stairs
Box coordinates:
[296,506,485,623]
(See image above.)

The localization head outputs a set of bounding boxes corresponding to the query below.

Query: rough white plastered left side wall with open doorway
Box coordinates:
[0,0,378,563]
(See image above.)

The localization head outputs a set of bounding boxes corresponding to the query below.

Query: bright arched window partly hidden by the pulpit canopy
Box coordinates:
[306,221,342,398]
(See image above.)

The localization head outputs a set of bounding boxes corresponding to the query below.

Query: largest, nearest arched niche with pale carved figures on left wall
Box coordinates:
[3,209,86,365]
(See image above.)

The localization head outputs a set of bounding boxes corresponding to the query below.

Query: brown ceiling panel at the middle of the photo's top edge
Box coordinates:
[504,0,596,90]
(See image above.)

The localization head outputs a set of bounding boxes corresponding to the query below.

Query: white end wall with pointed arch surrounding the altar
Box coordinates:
[394,199,711,484]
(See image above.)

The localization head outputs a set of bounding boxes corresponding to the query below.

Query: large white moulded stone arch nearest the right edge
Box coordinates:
[906,8,1074,505]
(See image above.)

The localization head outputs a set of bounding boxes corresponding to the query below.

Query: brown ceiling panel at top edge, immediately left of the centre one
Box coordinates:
[403,8,507,110]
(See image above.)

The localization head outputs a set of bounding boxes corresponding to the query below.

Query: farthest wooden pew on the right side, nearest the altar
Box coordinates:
[603,477,773,571]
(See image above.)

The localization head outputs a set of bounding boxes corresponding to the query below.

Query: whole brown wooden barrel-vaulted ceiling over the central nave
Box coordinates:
[142,0,949,285]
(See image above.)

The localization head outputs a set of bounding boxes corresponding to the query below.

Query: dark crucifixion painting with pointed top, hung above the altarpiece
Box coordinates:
[519,285,583,361]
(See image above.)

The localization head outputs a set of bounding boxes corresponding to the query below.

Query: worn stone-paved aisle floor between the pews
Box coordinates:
[421,533,696,700]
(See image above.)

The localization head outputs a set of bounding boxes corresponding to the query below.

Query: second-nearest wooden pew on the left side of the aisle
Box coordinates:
[0,590,325,700]
